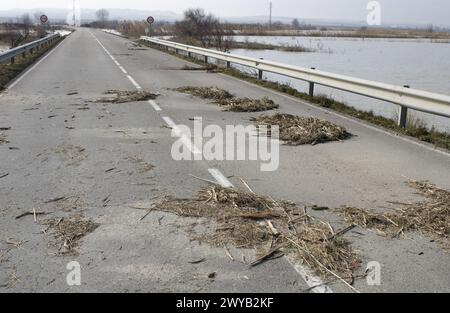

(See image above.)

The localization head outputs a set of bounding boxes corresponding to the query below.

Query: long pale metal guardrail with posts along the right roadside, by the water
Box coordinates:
[141,36,450,127]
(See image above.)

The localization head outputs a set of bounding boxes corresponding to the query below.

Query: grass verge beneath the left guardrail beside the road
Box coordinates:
[0,38,64,91]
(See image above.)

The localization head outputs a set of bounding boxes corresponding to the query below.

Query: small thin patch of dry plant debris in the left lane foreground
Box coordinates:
[44,217,100,255]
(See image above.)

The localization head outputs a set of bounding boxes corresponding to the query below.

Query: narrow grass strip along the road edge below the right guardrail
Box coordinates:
[143,42,450,150]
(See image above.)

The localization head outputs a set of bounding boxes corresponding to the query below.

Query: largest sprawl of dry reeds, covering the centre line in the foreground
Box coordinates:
[155,185,361,277]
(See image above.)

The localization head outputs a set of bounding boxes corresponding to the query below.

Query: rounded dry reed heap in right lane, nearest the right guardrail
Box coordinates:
[252,114,350,145]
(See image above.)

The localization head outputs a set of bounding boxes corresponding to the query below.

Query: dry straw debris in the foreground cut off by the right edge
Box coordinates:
[337,181,450,251]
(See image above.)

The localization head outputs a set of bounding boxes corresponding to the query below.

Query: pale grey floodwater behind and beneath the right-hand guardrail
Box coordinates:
[232,36,450,132]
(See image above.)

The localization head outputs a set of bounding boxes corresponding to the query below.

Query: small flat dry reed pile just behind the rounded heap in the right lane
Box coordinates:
[216,97,280,112]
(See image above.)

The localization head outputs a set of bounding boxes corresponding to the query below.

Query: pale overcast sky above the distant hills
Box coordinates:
[0,0,450,25]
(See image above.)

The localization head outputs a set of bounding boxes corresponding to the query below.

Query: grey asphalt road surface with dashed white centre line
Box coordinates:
[0,29,450,292]
